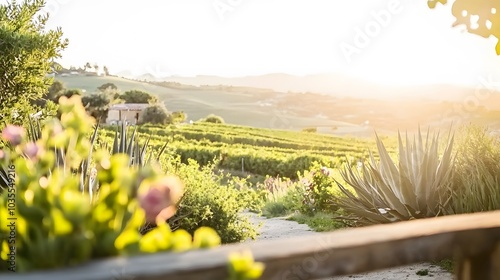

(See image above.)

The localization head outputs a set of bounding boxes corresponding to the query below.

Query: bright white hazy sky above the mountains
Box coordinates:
[33,0,500,85]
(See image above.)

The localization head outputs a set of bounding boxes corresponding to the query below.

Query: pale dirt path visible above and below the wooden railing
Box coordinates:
[245,213,453,280]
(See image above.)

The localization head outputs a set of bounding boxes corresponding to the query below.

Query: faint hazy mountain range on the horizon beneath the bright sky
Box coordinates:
[117,71,482,101]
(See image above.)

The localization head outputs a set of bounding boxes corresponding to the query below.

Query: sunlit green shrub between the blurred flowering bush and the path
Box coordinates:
[163,159,257,243]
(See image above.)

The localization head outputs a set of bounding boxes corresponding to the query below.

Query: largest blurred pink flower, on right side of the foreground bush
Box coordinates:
[139,176,183,223]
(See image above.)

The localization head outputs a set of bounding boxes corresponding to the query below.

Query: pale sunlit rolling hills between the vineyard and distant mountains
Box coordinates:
[57,76,500,137]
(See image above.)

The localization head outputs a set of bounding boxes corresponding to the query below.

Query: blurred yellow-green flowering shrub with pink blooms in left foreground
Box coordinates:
[0,96,220,271]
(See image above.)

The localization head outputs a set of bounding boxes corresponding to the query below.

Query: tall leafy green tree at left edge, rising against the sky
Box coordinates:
[0,0,67,128]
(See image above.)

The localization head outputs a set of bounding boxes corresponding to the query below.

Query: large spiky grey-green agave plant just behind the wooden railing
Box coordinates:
[335,130,454,225]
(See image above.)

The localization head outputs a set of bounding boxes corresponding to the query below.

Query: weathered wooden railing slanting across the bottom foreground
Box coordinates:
[0,211,500,280]
